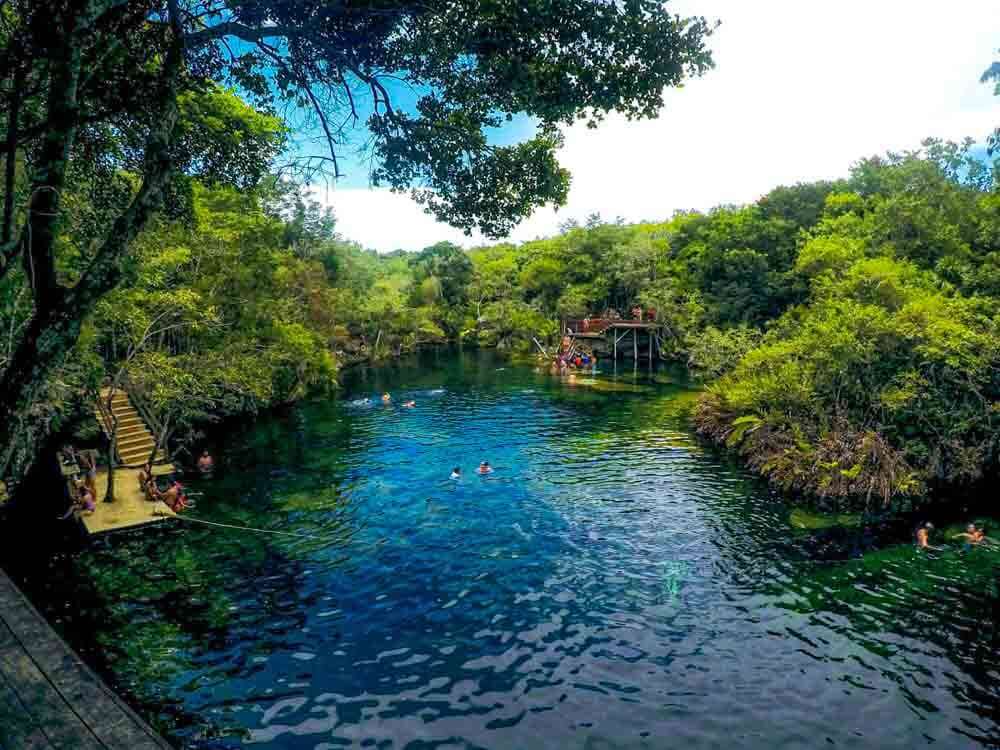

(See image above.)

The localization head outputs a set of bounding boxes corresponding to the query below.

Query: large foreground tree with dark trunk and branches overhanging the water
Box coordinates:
[0,0,711,488]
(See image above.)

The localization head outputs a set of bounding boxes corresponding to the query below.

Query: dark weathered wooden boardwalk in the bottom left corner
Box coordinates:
[0,570,170,750]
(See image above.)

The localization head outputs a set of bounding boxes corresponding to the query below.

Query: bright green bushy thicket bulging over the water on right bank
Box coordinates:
[695,142,1000,503]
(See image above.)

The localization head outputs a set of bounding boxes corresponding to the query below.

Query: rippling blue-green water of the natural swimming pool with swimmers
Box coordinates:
[3,351,1000,750]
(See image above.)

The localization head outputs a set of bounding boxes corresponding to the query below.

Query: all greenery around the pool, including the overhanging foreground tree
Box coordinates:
[0,0,1000,505]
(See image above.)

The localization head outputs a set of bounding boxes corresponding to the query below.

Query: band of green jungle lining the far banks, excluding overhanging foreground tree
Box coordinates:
[6,141,1000,505]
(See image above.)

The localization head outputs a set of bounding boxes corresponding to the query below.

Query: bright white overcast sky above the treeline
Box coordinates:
[308,0,1000,252]
